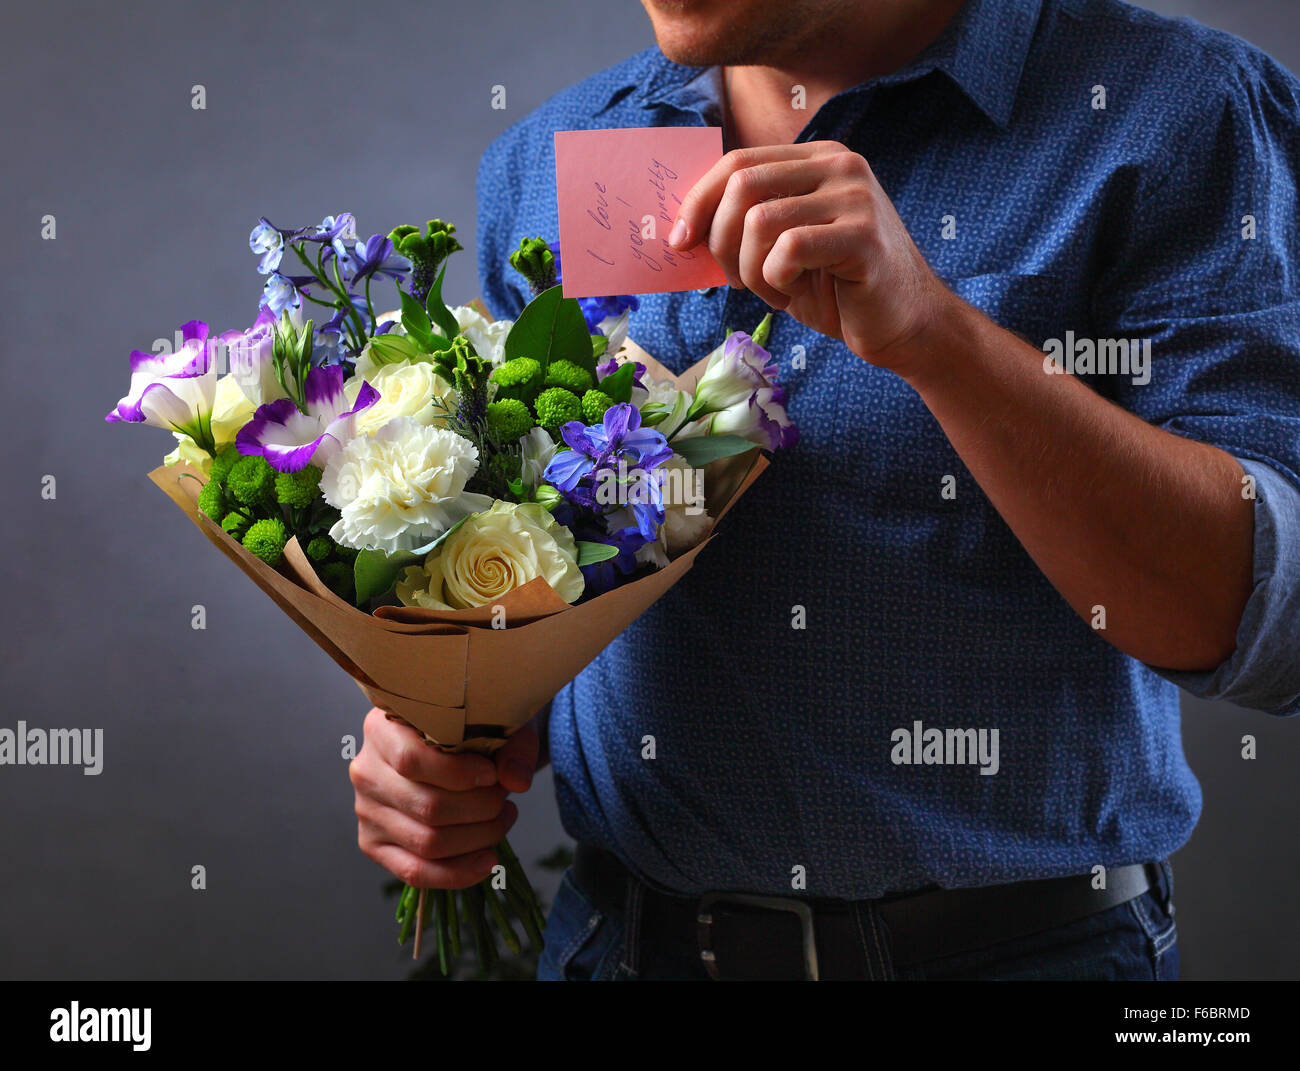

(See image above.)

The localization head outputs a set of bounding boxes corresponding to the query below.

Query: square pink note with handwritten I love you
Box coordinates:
[555,126,727,298]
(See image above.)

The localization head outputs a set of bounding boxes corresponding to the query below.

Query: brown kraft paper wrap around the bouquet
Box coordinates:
[150,341,767,753]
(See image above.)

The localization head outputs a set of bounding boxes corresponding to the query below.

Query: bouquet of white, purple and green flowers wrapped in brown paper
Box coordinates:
[107,214,797,972]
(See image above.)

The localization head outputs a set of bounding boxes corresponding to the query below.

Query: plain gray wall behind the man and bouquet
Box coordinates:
[0,0,1300,979]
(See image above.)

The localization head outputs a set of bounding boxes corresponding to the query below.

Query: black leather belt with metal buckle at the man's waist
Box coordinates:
[573,845,1158,980]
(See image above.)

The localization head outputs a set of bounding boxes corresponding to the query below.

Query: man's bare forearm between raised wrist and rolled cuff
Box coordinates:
[898,296,1255,669]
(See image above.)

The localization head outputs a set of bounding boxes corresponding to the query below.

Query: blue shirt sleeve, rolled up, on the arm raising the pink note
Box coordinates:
[1095,57,1300,715]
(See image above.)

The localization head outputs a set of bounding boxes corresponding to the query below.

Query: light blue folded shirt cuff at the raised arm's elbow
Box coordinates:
[1148,458,1300,716]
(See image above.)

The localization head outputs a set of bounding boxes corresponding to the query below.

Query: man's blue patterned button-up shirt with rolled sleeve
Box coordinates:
[478,0,1300,898]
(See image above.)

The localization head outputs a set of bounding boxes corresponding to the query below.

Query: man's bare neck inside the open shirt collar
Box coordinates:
[723,0,965,148]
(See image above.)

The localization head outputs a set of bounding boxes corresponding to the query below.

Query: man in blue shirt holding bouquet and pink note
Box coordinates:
[352,0,1300,979]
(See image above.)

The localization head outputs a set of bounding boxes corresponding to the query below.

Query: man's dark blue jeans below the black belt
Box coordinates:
[537,863,1178,981]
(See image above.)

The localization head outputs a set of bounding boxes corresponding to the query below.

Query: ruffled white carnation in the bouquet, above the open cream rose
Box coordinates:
[321,416,491,554]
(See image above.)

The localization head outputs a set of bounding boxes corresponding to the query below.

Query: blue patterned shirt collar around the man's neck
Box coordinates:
[624,0,1043,129]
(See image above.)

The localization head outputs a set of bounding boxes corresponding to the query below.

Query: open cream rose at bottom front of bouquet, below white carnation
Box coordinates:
[397,502,584,610]
